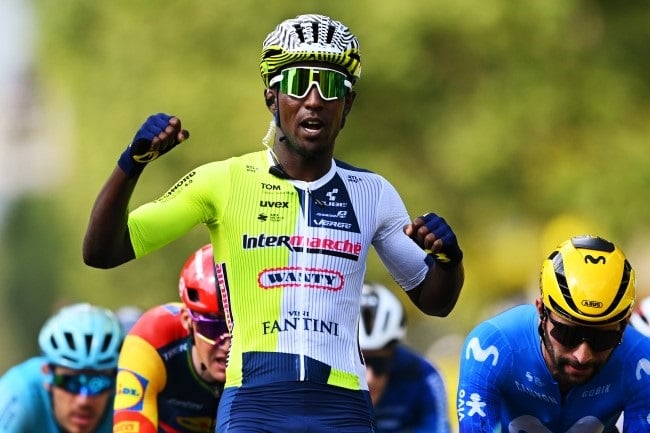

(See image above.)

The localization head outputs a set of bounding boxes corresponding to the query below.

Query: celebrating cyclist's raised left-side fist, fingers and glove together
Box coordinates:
[117,113,190,177]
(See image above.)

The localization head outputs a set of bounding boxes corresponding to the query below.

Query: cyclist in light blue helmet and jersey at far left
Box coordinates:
[0,303,123,433]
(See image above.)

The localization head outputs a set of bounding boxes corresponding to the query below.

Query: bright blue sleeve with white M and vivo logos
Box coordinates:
[456,322,512,433]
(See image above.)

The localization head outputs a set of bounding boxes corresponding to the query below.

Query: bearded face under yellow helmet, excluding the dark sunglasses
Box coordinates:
[540,296,620,387]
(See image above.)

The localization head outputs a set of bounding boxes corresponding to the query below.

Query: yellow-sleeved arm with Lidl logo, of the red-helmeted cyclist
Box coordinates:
[113,334,167,433]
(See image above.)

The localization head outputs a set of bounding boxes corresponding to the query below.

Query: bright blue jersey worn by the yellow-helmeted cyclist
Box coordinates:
[457,305,650,433]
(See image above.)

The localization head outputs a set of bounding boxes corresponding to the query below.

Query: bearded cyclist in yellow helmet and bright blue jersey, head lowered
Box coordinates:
[457,236,650,433]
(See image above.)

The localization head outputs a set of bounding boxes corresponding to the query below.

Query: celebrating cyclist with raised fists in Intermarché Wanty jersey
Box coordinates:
[83,15,464,433]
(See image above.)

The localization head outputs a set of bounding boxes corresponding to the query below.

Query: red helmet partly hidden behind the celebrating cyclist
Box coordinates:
[178,244,223,316]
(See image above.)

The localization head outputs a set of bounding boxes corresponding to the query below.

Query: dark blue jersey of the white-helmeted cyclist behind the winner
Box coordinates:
[374,345,451,433]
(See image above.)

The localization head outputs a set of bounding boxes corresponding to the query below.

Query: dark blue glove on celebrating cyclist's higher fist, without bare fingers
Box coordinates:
[117,113,189,177]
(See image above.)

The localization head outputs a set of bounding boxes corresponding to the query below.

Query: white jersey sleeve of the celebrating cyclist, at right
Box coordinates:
[373,176,429,290]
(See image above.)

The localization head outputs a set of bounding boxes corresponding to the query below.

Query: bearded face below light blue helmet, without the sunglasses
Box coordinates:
[51,367,114,433]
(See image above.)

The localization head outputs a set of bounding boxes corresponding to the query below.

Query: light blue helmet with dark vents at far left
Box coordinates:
[38,303,124,370]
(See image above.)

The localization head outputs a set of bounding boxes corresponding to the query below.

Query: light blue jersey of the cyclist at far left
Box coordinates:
[0,357,113,433]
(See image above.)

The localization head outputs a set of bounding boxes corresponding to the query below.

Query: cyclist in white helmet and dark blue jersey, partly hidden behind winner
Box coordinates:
[359,284,451,433]
